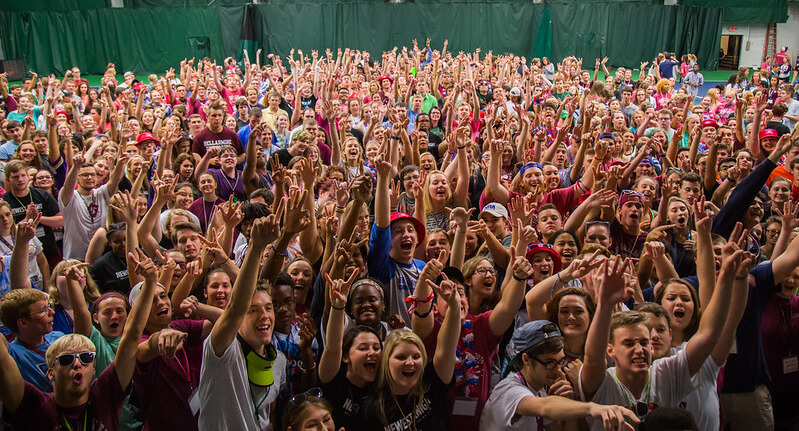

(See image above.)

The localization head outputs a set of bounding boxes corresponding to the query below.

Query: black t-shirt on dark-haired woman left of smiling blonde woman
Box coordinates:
[319,364,373,431]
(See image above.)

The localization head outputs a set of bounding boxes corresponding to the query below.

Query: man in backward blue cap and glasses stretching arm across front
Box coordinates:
[480,320,638,431]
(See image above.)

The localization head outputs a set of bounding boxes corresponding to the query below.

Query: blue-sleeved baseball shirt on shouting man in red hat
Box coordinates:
[367,224,425,327]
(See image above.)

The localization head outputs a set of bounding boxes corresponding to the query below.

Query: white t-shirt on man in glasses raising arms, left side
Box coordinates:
[58,184,111,261]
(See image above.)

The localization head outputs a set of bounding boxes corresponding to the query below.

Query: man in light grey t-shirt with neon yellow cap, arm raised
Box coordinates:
[200,190,312,431]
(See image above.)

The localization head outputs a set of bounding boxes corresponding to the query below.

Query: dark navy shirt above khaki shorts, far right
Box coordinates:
[683,262,780,393]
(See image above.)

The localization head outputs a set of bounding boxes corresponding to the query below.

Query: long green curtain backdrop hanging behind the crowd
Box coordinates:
[0,0,723,74]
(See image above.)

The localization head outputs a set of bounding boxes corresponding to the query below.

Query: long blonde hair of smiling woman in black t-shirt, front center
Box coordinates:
[377,329,428,424]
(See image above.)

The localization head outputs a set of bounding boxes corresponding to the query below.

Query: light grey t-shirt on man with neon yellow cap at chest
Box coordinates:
[199,337,286,431]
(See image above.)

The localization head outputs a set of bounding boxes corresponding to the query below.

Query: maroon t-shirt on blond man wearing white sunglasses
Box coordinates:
[3,363,127,431]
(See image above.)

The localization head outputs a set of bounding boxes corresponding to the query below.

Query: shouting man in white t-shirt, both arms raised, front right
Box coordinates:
[579,208,743,430]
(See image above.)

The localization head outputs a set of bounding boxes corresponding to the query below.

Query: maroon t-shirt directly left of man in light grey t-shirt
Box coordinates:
[133,320,203,431]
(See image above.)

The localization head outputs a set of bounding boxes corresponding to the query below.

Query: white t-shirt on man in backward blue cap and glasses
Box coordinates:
[480,373,552,431]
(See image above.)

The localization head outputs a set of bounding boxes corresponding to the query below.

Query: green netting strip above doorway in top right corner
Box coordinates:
[680,0,788,24]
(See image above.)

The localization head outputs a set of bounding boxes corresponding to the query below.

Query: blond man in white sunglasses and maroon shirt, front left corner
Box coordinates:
[0,245,158,430]
